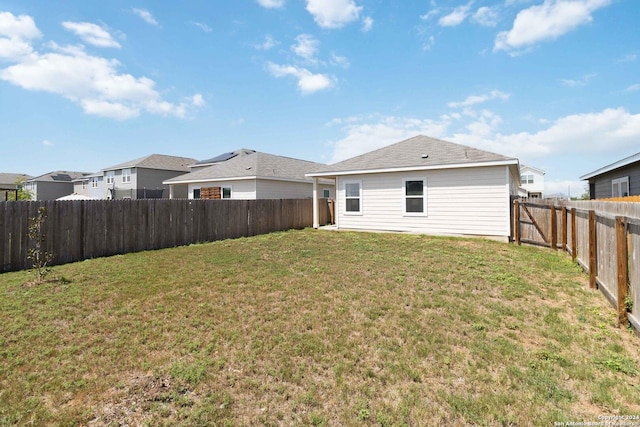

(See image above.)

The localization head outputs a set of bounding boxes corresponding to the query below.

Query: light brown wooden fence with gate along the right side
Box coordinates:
[512,200,640,331]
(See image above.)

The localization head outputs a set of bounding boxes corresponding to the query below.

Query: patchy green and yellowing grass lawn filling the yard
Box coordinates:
[0,230,640,426]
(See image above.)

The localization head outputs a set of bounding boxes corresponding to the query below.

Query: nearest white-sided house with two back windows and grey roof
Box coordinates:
[307,135,520,238]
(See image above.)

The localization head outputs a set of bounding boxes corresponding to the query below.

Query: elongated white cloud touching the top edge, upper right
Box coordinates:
[493,0,611,51]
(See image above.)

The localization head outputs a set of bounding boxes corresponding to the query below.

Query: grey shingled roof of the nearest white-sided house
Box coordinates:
[307,135,518,176]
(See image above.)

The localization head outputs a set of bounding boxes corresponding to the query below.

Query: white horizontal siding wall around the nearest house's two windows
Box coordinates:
[336,166,510,236]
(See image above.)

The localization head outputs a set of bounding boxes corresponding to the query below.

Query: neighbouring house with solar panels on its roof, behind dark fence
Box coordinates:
[164,148,334,200]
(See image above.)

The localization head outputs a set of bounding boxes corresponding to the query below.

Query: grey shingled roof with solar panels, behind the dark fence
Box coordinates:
[164,150,324,184]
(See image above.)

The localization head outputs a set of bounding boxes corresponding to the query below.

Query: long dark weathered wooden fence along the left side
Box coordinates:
[0,199,329,273]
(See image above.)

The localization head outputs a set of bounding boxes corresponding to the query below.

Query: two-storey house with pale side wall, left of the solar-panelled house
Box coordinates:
[102,154,196,199]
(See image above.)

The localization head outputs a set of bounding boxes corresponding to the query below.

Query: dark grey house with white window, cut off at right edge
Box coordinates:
[580,153,640,199]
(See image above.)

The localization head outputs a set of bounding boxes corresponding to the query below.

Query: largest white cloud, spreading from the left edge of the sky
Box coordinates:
[0,12,204,119]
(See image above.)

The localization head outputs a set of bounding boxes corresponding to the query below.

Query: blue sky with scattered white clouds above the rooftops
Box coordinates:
[0,0,640,195]
